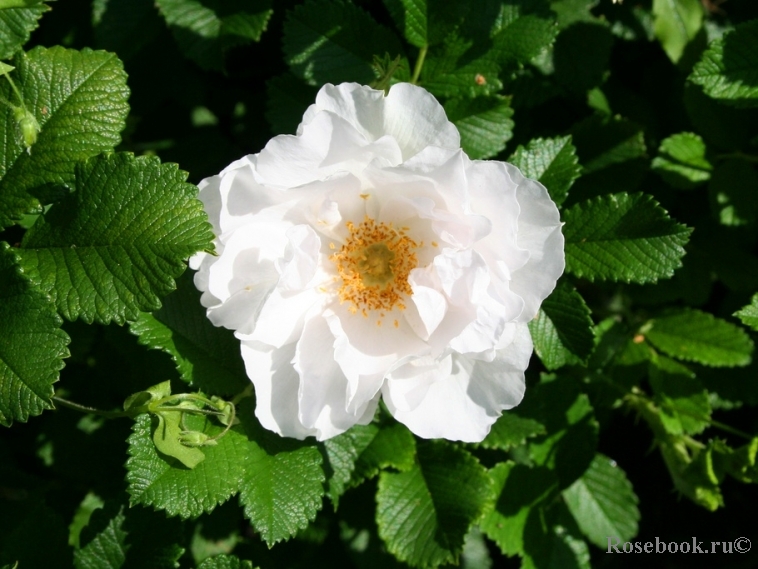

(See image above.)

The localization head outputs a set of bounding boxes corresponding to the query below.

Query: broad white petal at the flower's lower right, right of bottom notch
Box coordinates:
[383,324,532,442]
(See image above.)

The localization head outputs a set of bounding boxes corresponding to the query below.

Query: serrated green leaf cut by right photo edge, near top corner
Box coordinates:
[689,20,758,107]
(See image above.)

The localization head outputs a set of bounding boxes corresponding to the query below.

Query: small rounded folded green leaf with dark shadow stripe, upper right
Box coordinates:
[652,132,713,190]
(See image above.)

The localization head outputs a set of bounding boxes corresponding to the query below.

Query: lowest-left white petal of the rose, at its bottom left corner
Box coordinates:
[242,342,316,439]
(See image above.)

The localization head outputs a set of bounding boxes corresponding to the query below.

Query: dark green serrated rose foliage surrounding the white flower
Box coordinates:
[0,0,758,569]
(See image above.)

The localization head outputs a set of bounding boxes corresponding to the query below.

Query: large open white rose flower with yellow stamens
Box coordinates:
[191,83,564,442]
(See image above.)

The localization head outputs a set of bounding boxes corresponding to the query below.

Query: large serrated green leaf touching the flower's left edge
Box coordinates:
[21,153,213,323]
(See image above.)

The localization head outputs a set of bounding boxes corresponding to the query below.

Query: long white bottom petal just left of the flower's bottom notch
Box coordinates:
[293,316,379,440]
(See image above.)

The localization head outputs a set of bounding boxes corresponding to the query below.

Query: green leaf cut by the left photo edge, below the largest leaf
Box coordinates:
[0,242,69,427]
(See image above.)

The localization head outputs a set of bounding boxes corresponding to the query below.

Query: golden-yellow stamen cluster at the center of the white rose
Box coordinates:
[330,216,419,316]
